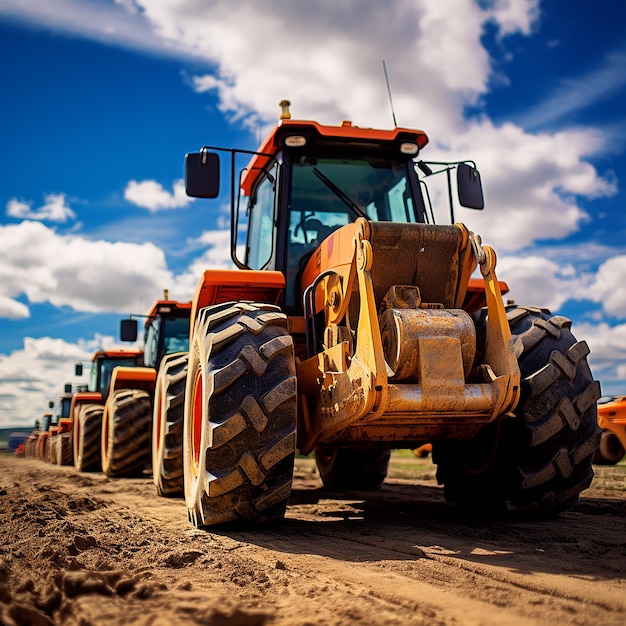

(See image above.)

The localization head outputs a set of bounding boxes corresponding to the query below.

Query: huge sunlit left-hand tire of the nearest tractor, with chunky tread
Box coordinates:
[183,302,296,527]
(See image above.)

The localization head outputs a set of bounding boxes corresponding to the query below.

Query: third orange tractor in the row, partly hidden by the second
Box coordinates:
[70,350,143,472]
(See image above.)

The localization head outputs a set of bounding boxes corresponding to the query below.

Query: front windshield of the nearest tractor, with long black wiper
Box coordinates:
[286,156,421,305]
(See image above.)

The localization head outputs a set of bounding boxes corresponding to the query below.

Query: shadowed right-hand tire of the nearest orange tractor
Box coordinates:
[433,307,600,515]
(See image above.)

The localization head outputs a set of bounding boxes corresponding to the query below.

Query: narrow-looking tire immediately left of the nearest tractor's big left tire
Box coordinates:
[152,352,189,496]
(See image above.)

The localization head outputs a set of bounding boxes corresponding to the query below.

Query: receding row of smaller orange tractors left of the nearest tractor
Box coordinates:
[23,294,191,495]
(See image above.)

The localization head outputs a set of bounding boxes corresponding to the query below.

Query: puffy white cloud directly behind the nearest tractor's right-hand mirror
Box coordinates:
[444,119,617,252]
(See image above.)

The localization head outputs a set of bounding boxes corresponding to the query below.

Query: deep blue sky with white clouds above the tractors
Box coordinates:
[0,0,626,427]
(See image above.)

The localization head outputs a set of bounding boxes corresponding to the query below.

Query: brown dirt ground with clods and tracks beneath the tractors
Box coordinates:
[0,454,626,626]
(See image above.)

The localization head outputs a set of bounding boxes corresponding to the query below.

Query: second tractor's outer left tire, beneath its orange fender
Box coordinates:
[101,389,152,478]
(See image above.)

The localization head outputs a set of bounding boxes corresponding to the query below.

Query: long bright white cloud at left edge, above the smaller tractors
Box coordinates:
[0,221,192,312]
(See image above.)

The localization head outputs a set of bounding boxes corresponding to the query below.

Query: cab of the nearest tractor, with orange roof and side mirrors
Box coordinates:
[185,105,483,313]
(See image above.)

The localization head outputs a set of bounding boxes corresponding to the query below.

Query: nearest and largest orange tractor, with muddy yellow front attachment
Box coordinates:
[183,102,600,527]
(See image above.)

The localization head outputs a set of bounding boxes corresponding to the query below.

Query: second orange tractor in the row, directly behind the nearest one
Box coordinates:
[116,291,191,482]
